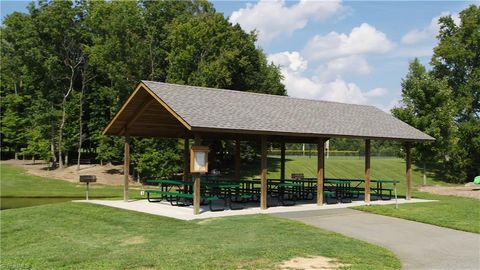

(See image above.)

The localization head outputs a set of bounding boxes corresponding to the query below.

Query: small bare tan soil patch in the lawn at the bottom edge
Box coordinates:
[278,256,348,270]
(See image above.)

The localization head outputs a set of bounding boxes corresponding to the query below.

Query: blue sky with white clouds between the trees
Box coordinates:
[1,0,478,111]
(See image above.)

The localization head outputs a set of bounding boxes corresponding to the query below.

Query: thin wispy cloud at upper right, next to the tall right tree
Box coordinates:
[402,11,460,45]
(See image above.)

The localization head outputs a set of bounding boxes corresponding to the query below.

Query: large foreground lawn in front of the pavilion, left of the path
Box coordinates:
[0,203,401,269]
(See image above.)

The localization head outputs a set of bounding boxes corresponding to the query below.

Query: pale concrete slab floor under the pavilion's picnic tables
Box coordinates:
[75,199,432,220]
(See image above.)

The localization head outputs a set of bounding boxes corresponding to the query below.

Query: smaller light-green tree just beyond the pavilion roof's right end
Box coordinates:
[392,59,461,181]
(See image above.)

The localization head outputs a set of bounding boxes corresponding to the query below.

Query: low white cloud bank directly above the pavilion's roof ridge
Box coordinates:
[268,51,387,104]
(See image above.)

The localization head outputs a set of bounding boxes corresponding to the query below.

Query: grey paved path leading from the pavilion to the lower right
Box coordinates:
[273,209,480,269]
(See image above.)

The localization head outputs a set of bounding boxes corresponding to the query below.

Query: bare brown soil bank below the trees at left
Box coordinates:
[2,159,135,185]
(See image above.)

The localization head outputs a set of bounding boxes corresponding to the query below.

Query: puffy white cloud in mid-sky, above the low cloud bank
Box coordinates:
[303,23,394,60]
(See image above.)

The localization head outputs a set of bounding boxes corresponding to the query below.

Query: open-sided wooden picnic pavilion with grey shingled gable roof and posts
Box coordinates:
[103,81,434,214]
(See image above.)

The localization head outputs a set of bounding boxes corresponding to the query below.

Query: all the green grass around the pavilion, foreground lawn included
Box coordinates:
[0,158,480,269]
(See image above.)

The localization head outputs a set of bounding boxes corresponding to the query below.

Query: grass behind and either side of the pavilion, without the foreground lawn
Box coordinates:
[0,157,480,233]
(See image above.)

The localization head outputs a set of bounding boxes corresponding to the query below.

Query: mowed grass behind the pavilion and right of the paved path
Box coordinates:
[244,157,480,233]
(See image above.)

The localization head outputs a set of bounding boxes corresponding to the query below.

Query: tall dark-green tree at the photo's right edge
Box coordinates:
[430,5,480,181]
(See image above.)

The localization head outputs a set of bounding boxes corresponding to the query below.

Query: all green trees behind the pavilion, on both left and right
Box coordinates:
[0,0,480,182]
